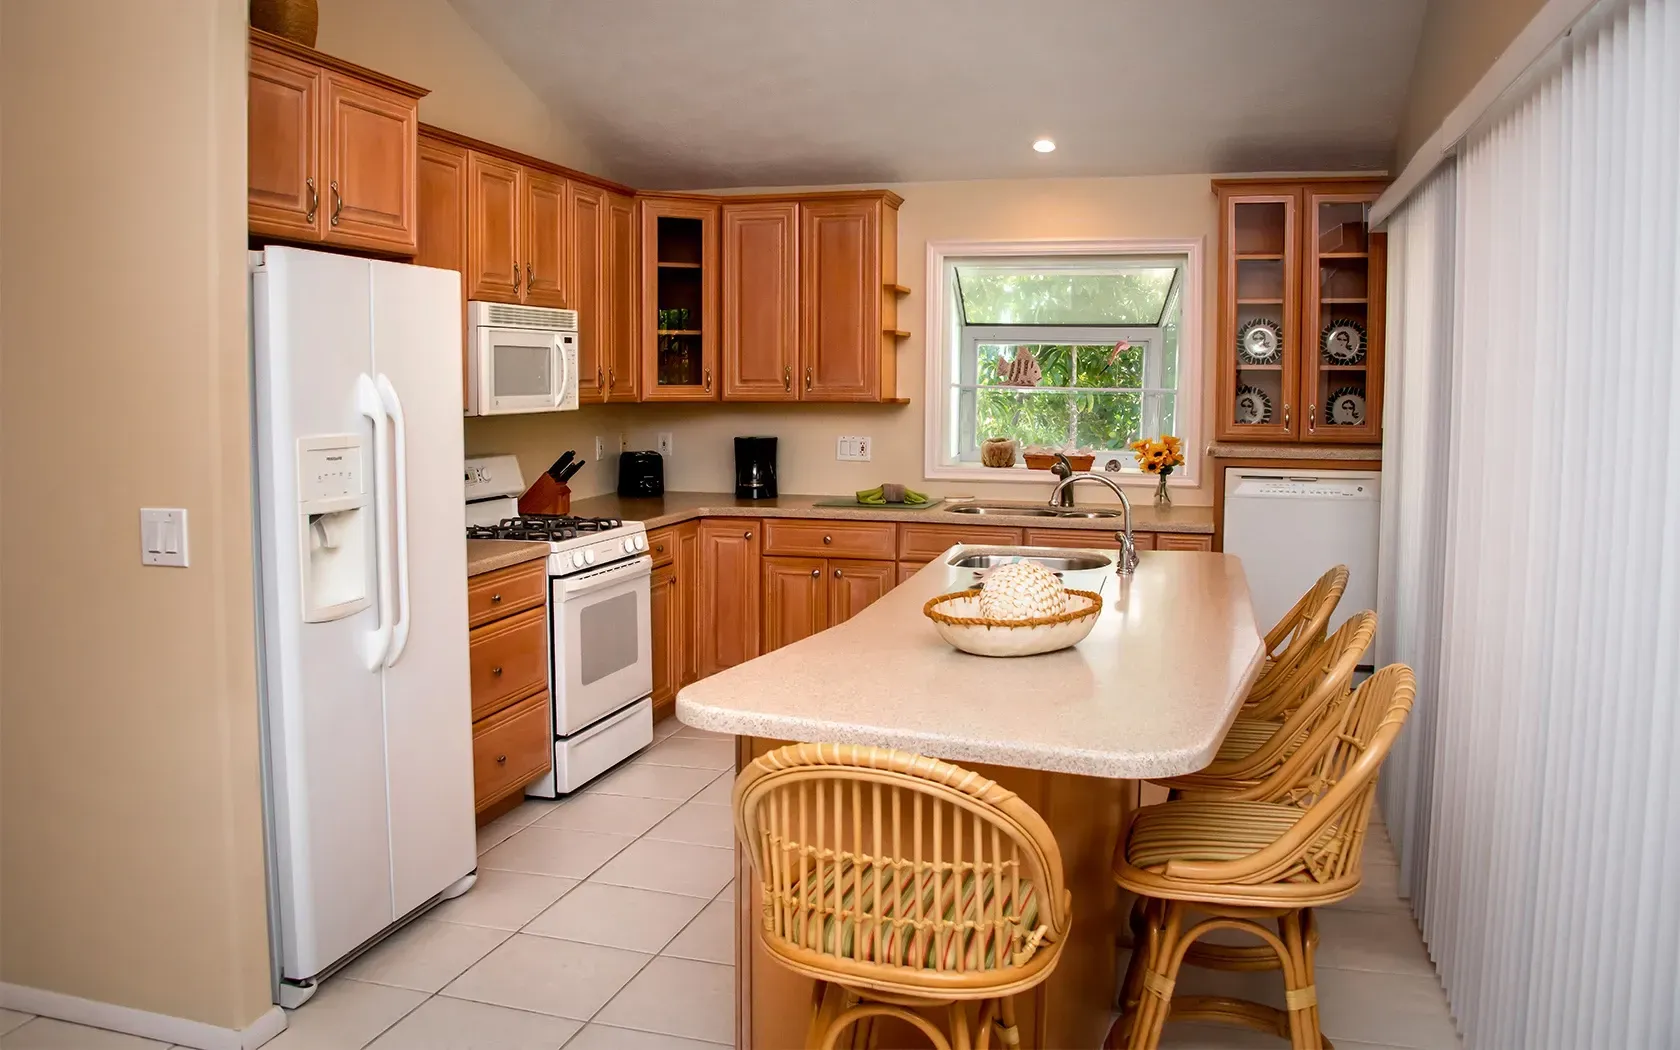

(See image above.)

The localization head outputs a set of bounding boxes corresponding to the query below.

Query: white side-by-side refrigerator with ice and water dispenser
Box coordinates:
[250,247,477,1006]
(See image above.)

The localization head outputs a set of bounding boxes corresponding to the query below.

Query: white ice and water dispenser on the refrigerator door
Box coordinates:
[297,433,373,623]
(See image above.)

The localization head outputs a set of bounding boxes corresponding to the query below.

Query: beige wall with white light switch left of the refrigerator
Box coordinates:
[0,0,269,1026]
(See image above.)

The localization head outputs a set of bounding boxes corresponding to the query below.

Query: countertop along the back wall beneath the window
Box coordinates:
[571,492,1213,534]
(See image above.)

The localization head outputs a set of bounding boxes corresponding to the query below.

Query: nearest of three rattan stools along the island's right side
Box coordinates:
[1107,664,1415,1050]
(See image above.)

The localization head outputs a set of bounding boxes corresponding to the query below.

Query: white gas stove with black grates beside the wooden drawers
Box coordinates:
[465,455,654,798]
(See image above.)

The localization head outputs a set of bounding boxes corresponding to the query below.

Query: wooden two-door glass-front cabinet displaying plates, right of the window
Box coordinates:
[1215,180,1386,444]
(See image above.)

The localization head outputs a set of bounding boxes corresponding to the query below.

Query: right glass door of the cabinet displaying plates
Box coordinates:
[1300,185,1388,444]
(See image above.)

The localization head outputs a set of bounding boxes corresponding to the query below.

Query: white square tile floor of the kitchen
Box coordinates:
[0,719,1458,1050]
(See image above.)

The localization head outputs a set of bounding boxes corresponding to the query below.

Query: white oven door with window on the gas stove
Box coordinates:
[548,556,654,736]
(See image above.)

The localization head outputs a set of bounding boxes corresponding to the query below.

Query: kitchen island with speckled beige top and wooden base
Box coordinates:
[677,546,1263,1050]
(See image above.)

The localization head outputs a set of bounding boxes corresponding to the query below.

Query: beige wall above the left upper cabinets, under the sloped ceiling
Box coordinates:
[316,0,612,176]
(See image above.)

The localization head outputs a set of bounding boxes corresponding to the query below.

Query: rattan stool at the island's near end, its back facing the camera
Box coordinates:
[734,744,1070,1050]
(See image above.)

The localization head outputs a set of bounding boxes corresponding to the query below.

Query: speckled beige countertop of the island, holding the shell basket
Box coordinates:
[677,546,1265,780]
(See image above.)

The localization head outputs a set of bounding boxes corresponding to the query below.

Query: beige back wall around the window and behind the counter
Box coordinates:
[467,175,1218,504]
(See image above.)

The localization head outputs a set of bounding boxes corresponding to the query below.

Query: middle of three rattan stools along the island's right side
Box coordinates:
[1154,612,1376,798]
